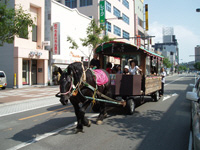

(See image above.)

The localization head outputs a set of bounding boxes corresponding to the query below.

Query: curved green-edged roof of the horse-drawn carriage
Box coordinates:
[95,41,164,59]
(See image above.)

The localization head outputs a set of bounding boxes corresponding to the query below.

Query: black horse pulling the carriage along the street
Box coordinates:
[59,62,110,132]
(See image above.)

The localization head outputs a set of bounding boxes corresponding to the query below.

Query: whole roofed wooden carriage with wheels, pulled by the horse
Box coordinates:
[93,41,163,114]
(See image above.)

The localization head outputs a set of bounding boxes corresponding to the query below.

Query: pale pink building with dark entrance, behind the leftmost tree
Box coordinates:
[0,0,49,88]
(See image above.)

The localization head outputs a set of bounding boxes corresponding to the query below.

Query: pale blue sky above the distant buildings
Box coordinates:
[144,0,200,63]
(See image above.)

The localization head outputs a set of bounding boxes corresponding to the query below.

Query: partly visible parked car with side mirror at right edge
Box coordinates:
[186,79,200,150]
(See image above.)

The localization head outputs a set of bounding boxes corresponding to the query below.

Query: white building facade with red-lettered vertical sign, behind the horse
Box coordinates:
[45,0,92,84]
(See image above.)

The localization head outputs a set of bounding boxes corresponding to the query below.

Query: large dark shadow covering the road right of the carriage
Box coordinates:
[106,78,191,150]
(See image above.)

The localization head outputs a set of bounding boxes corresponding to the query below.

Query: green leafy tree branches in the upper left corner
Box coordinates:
[0,3,33,46]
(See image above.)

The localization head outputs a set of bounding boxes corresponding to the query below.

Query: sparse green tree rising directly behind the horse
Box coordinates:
[67,19,114,61]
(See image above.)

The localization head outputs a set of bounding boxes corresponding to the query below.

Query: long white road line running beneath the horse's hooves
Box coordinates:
[7,114,99,150]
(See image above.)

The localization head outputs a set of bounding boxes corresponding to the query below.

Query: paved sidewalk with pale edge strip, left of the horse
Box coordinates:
[0,86,60,117]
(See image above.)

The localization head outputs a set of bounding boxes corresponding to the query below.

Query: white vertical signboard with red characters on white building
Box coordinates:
[53,22,60,55]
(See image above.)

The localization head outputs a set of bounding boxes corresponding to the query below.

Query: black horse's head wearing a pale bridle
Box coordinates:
[59,68,74,105]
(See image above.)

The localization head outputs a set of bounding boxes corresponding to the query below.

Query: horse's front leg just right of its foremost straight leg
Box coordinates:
[80,100,91,127]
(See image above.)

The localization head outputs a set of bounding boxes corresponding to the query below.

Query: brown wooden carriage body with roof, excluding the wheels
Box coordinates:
[96,41,163,96]
